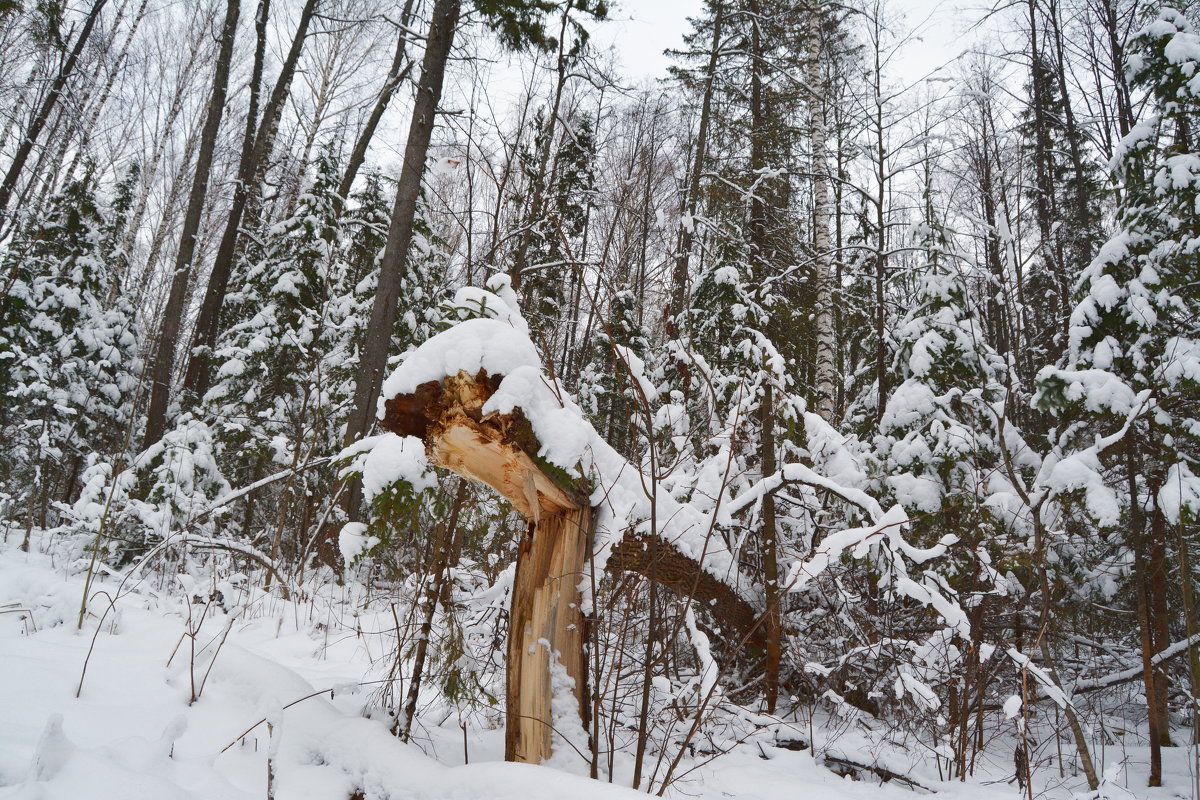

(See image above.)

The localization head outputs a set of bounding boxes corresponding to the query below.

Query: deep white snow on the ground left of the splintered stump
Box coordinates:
[0,537,625,800]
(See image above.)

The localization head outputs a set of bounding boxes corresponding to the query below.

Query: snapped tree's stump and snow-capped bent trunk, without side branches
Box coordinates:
[378,309,763,763]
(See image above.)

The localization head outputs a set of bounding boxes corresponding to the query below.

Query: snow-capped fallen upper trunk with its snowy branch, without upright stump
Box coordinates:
[369,284,970,636]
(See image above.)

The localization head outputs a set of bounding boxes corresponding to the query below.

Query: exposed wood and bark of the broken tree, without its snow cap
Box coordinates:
[380,371,763,763]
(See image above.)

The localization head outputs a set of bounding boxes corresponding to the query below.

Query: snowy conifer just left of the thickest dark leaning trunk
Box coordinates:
[204,149,341,551]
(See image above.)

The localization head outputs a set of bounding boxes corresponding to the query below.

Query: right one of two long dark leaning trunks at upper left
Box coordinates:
[184,0,320,398]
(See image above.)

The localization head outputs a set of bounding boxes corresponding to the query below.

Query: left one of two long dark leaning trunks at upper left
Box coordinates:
[142,0,241,449]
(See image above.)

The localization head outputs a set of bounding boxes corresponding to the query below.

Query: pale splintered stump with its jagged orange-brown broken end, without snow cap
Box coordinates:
[383,372,594,763]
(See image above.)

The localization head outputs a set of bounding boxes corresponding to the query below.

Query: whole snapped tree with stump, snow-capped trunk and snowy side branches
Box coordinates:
[355,287,970,763]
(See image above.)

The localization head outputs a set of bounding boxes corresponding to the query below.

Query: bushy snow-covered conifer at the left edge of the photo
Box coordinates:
[0,174,140,516]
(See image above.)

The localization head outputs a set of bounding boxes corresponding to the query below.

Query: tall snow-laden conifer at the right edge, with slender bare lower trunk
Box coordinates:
[1037,10,1200,786]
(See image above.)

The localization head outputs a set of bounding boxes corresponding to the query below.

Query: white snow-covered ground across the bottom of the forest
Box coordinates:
[0,533,1194,800]
